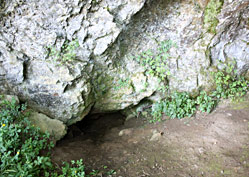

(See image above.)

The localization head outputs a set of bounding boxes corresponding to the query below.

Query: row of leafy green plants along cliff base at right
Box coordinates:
[150,64,249,123]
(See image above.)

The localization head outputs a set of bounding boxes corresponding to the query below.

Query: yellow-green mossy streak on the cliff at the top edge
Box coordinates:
[204,0,224,34]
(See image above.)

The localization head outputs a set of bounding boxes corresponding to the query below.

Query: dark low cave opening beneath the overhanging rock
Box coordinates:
[58,112,125,143]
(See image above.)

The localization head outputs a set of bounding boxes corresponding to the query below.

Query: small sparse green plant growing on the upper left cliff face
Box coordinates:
[47,40,79,64]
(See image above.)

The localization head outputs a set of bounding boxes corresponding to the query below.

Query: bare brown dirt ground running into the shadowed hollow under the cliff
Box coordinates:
[52,96,249,177]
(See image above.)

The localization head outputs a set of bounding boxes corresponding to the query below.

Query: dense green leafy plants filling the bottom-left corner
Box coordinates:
[0,97,115,177]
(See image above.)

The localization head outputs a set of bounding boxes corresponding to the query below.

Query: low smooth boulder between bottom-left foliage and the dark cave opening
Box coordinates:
[29,111,67,141]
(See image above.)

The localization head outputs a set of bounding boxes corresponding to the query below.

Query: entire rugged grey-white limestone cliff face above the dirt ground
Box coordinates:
[0,0,249,125]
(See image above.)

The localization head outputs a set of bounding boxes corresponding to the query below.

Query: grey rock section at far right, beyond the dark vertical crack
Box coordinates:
[210,0,249,74]
